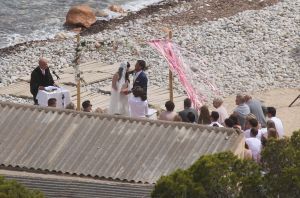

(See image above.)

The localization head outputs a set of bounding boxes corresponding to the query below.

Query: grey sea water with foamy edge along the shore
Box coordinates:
[0,0,161,48]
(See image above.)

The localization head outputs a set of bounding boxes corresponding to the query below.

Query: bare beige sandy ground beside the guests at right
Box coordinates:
[224,89,300,136]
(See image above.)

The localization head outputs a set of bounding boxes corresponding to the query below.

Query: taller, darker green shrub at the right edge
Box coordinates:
[262,130,300,197]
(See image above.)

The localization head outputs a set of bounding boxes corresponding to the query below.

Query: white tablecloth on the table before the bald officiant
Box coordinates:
[36,88,71,108]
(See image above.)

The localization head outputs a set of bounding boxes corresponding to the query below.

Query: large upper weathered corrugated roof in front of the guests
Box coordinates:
[0,102,244,183]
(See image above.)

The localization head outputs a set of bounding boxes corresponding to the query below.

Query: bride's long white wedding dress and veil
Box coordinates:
[108,63,129,116]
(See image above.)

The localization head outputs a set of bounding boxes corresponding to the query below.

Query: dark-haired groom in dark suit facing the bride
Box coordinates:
[133,60,148,96]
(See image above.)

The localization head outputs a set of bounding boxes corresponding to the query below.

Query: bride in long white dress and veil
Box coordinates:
[108,63,130,116]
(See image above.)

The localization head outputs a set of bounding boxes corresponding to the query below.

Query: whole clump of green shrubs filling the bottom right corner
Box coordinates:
[152,130,300,198]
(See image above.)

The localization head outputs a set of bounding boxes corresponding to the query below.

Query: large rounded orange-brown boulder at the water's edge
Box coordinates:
[66,5,96,28]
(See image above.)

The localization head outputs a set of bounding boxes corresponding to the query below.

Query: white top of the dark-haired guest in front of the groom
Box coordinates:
[128,96,148,118]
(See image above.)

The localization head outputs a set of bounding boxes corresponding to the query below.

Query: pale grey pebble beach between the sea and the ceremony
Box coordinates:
[0,0,300,102]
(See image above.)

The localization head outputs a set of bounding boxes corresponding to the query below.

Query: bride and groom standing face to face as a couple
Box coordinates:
[108,60,148,117]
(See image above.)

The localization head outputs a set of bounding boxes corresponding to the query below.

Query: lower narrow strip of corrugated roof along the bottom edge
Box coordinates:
[0,170,153,198]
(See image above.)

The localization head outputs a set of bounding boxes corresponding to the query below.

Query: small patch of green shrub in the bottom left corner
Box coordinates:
[0,176,44,198]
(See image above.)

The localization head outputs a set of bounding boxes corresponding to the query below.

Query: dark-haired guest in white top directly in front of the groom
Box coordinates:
[128,86,148,118]
